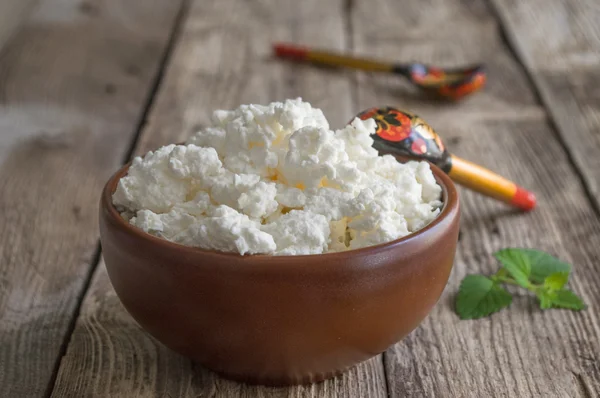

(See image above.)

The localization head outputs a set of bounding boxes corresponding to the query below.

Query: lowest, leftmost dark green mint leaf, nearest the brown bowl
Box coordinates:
[456,275,512,319]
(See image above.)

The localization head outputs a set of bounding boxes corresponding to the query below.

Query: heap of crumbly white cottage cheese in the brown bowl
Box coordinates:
[113,99,441,255]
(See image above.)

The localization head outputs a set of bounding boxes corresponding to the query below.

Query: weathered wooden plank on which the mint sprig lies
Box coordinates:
[353,0,600,397]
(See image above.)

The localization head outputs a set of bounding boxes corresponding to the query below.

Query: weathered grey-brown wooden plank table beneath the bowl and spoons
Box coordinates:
[0,0,600,398]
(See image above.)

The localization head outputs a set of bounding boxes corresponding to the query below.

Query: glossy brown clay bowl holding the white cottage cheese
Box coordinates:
[100,155,459,385]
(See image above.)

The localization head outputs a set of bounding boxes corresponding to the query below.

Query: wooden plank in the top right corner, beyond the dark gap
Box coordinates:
[490,0,600,213]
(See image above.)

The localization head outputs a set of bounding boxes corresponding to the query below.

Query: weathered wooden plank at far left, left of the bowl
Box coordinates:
[0,0,184,397]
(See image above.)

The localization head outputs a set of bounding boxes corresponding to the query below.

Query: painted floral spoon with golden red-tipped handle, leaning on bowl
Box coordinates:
[357,107,536,211]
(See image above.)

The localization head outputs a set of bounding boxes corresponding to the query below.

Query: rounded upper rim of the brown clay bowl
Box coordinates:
[101,153,459,271]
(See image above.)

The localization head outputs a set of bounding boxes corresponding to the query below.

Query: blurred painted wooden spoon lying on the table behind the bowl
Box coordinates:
[273,43,486,100]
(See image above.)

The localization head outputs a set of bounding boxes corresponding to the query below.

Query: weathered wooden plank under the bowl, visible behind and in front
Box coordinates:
[53,0,386,397]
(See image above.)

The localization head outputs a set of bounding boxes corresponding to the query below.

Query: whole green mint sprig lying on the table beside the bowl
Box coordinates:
[456,248,585,319]
